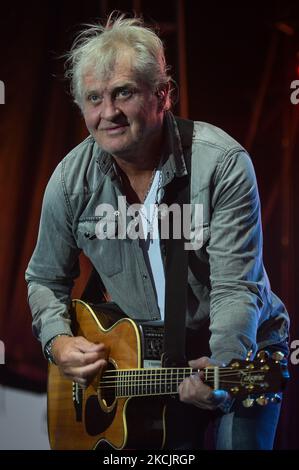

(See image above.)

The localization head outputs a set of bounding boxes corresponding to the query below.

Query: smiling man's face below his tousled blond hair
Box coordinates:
[82,54,163,161]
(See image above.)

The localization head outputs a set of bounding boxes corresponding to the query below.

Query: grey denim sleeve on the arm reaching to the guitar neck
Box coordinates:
[207,151,265,363]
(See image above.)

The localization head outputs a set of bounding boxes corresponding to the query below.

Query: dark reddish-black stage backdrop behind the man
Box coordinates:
[0,0,299,449]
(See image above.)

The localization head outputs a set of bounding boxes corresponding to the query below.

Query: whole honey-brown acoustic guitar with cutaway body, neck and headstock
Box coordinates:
[48,300,288,450]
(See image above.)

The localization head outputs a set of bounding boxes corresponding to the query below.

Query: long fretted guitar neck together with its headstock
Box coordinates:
[99,360,289,398]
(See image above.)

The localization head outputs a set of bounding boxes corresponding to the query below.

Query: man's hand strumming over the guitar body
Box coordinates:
[52,336,108,386]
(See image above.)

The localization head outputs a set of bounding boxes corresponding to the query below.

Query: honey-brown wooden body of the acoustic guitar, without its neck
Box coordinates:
[48,300,165,450]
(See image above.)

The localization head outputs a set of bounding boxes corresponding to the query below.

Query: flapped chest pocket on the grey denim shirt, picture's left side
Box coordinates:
[77,217,123,277]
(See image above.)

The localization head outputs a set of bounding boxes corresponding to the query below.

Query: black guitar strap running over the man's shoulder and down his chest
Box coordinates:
[163,118,194,367]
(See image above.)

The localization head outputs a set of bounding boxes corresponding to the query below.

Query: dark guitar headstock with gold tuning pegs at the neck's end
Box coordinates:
[207,351,289,407]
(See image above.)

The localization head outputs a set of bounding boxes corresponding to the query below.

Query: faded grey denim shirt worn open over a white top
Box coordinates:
[26,112,289,362]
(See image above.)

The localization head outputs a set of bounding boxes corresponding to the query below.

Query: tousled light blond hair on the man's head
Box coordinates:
[66,12,171,109]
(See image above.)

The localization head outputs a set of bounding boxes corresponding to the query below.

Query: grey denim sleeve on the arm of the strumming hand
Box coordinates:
[25,163,80,349]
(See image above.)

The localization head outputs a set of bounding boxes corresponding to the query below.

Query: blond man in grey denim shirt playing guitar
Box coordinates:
[26,12,288,449]
